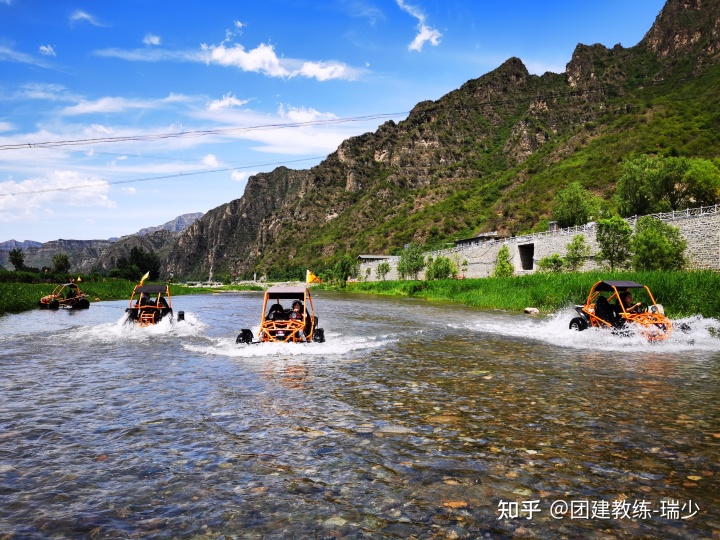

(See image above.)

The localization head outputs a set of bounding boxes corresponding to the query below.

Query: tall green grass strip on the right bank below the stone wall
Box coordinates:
[345,270,720,318]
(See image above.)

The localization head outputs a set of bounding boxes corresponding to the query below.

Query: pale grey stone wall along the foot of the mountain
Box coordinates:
[360,205,720,281]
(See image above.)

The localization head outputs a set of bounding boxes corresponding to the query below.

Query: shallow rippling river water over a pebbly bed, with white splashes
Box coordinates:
[0,292,720,539]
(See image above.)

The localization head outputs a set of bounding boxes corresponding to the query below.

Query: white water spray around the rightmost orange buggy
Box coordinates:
[448,309,720,354]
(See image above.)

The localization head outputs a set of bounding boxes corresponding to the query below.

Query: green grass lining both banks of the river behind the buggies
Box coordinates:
[0,270,720,319]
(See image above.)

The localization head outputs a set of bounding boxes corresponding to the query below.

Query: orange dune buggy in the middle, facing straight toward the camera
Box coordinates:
[235,286,325,343]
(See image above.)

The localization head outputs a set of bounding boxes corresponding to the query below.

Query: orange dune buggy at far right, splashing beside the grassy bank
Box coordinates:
[570,281,673,341]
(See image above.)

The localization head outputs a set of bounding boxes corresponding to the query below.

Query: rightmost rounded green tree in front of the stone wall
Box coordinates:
[632,216,687,270]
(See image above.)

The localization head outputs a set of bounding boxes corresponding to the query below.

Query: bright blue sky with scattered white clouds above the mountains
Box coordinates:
[0,0,664,242]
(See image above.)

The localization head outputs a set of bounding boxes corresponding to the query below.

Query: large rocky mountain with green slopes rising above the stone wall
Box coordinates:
[163,0,720,279]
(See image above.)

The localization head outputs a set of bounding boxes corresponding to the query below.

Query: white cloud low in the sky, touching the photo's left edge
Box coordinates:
[0,170,115,222]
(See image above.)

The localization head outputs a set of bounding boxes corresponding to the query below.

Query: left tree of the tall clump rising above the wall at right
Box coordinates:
[615,155,662,216]
